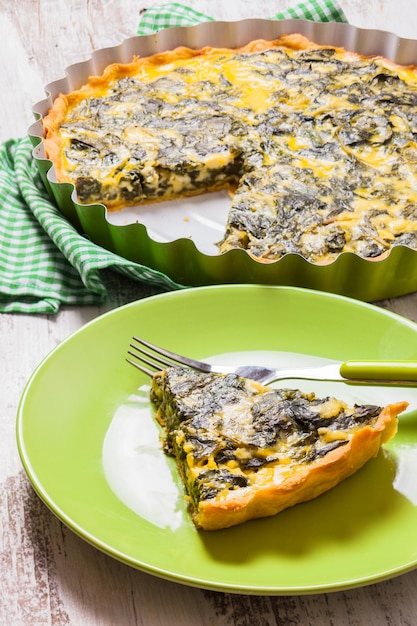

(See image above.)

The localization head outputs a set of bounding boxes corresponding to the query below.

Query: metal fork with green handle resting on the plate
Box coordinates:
[126,336,417,387]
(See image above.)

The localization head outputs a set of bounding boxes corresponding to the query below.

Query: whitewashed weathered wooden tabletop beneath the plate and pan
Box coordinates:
[0,0,417,626]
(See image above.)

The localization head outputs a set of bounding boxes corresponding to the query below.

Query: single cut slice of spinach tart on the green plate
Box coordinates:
[151,367,407,530]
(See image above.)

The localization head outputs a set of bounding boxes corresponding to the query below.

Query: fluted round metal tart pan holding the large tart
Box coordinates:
[29,19,417,301]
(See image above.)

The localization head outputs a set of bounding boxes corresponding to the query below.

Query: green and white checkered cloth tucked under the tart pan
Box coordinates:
[0,0,346,313]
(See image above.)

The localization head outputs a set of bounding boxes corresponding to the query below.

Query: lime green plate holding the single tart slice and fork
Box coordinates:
[17,285,417,595]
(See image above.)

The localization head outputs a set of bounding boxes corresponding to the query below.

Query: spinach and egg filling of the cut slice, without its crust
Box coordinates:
[151,367,381,506]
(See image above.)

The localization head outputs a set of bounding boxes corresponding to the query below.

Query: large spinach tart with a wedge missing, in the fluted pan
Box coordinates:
[43,34,417,264]
